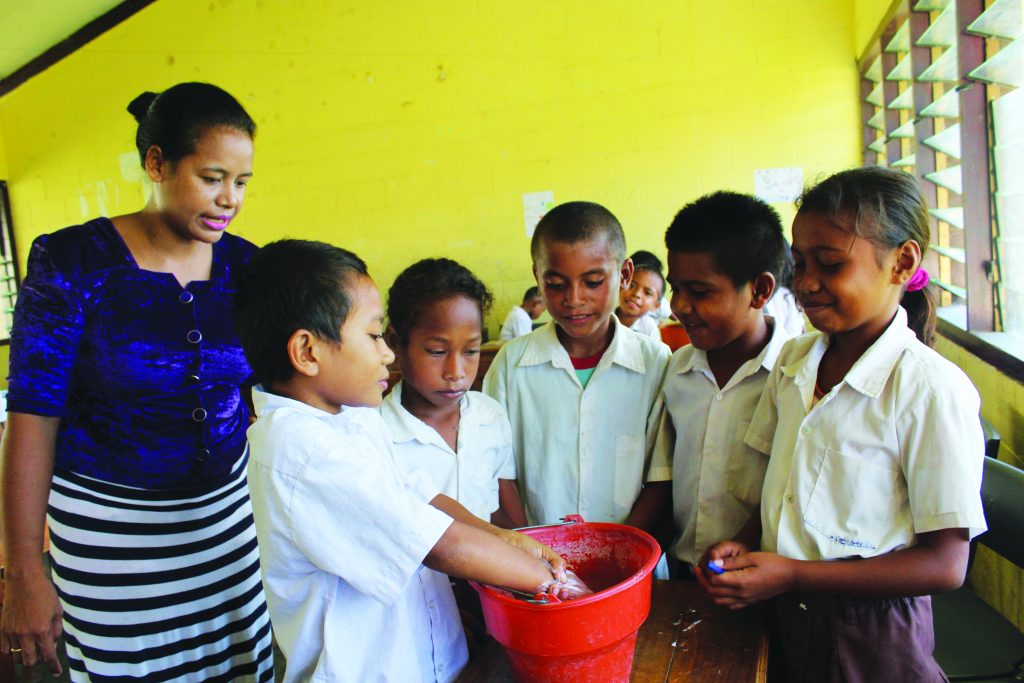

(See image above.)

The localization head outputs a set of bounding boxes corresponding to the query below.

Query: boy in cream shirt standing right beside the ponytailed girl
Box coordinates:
[655,191,790,578]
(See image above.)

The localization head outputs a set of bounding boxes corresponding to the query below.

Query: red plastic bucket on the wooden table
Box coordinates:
[472,515,662,683]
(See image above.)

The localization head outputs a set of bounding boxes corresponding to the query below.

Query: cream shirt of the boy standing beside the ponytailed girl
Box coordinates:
[655,317,790,564]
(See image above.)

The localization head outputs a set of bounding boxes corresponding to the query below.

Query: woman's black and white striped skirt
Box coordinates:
[49,450,273,683]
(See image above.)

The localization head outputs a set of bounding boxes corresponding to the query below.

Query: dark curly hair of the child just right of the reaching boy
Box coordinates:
[387,258,494,345]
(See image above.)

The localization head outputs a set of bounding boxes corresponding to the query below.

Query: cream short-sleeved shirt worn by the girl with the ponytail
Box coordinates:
[745,307,986,560]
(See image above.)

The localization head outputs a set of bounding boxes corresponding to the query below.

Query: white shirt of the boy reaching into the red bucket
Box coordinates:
[248,388,468,682]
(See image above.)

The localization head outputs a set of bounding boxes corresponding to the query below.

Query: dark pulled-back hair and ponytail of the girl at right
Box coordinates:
[797,166,935,346]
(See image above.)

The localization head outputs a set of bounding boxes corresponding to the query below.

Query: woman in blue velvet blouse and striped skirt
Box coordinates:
[0,83,273,682]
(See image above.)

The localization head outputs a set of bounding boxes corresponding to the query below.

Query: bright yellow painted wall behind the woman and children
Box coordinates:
[0,0,859,342]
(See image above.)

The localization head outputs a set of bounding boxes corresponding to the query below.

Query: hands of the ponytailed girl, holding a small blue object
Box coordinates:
[694,553,798,609]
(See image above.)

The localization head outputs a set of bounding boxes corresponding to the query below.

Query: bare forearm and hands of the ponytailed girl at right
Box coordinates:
[697,528,970,609]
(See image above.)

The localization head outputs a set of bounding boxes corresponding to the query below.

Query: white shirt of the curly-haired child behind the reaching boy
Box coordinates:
[381,382,516,521]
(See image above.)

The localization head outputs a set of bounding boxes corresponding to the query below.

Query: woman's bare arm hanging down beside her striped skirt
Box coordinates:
[0,413,63,675]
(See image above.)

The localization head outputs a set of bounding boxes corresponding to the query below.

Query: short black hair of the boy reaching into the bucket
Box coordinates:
[233,240,368,384]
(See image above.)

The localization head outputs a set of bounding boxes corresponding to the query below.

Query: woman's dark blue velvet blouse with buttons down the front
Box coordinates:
[7,218,256,488]
